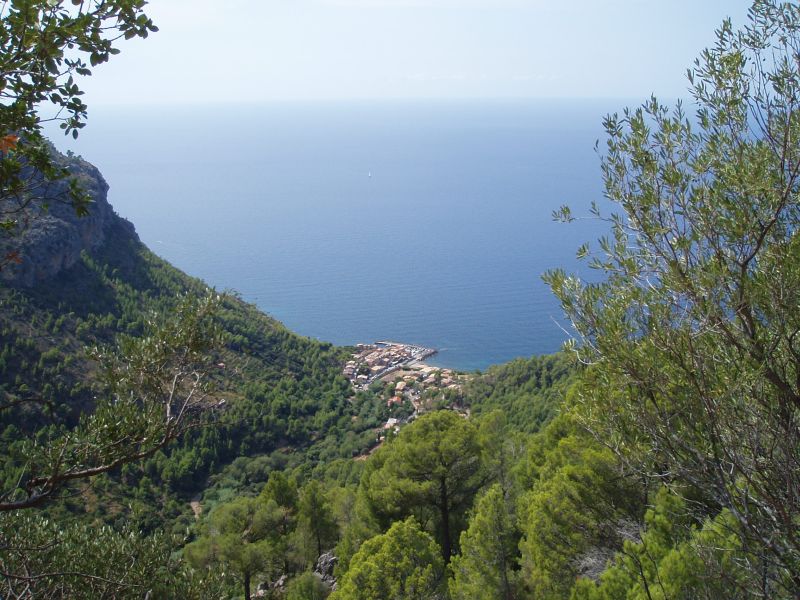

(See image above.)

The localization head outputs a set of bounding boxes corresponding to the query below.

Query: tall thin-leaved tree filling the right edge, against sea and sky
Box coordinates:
[547,0,800,595]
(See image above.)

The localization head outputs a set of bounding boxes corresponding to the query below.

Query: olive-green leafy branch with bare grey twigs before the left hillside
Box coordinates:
[0,296,220,511]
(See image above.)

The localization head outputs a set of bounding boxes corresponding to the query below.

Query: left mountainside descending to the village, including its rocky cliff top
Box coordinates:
[0,150,390,526]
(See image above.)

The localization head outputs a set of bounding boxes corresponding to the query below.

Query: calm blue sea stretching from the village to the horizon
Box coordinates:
[50,100,630,370]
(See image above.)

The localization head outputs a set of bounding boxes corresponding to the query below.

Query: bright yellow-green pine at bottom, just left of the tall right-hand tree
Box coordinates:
[518,416,646,599]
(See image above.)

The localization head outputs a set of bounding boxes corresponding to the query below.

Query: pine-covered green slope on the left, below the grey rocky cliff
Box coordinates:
[0,146,406,596]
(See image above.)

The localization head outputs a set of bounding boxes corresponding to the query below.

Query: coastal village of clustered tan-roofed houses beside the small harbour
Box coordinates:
[343,341,469,443]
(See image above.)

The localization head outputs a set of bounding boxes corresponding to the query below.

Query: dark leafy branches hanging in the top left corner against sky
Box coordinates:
[0,0,157,269]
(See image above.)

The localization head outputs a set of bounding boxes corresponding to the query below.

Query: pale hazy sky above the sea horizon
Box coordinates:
[83,0,750,106]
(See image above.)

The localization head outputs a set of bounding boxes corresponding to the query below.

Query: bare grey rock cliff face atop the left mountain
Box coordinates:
[0,157,138,287]
